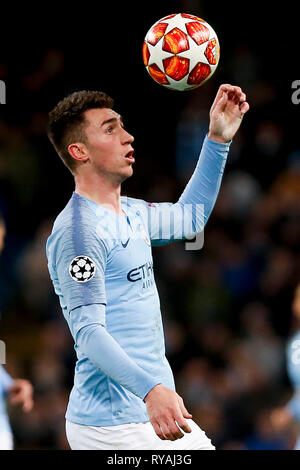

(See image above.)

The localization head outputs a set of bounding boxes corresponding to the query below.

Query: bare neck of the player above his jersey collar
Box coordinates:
[75,170,124,215]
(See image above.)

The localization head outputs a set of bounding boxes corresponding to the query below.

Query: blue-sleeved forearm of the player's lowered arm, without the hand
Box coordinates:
[72,305,160,399]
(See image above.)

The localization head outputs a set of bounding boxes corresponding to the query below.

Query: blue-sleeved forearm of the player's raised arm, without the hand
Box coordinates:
[178,137,230,228]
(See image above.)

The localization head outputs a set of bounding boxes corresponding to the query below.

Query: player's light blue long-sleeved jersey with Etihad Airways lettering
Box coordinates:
[47,138,229,426]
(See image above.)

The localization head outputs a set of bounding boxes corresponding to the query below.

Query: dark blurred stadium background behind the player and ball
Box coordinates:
[0,0,300,449]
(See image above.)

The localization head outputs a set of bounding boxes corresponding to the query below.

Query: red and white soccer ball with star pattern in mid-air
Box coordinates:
[143,13,220,91]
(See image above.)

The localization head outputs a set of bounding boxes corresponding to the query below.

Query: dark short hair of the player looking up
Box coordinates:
[47,90,114,173]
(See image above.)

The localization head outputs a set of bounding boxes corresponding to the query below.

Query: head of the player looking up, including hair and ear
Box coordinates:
[48,91,134,182]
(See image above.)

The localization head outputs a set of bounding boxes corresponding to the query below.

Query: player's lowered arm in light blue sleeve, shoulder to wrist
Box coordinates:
[53,227,158,399]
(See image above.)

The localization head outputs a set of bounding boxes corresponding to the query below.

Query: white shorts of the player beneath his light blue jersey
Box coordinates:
[66,419,215,450]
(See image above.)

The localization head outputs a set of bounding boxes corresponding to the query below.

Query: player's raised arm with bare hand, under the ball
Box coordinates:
[147,85,249,245]
